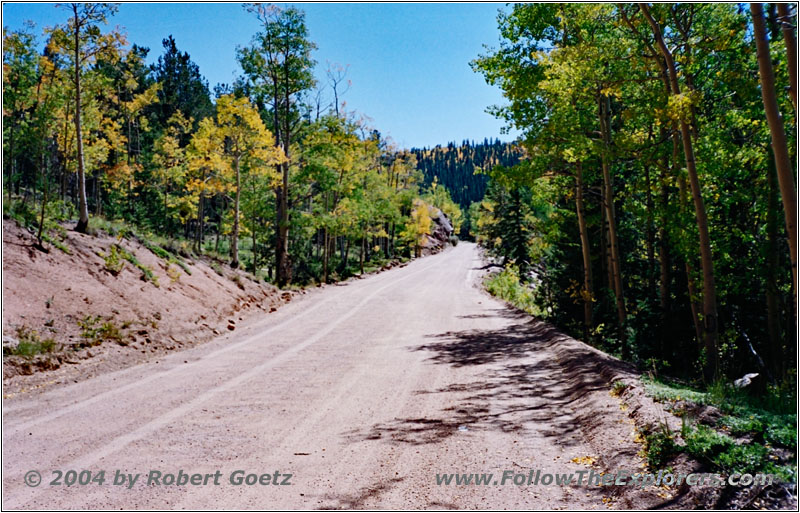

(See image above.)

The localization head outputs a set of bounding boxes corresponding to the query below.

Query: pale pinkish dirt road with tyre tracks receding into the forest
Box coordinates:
[3,243,663,509]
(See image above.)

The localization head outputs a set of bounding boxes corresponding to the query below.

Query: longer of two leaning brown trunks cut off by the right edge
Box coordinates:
[750,3,797,304]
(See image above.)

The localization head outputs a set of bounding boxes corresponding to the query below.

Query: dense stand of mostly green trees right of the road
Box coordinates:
[469,3,797,389]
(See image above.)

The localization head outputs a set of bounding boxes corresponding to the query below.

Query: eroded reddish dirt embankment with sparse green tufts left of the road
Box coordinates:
[3,220,294,397]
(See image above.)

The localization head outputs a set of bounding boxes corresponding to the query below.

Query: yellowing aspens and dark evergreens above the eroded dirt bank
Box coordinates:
[3,3,461,286]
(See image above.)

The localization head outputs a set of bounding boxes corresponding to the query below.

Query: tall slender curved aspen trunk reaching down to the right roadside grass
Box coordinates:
[639,3,719,379]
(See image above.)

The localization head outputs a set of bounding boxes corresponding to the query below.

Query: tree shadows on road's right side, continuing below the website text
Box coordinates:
[345,309,700,508]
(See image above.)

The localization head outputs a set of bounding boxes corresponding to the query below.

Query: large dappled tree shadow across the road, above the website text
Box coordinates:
[346,309,630,452]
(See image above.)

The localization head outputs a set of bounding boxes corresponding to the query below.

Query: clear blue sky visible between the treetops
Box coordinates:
[3,3,515,147]
